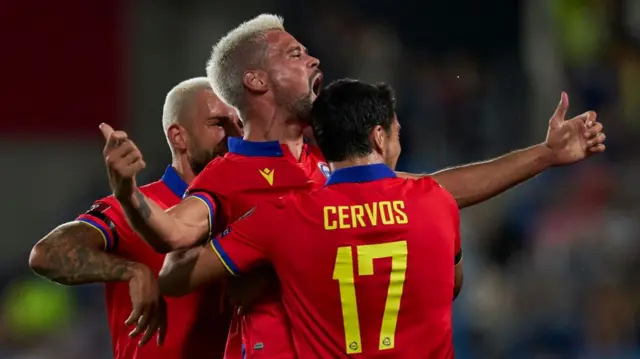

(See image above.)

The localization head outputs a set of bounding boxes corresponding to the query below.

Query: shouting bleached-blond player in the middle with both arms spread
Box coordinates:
[105,14,604,359]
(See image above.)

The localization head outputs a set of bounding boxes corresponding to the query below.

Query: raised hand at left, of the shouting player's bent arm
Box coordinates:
[100,123,146,199]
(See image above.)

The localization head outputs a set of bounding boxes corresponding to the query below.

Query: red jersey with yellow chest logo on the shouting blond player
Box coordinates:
[182,137,329,359]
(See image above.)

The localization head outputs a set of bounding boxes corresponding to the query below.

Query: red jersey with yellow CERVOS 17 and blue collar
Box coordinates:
[212,164,460,359]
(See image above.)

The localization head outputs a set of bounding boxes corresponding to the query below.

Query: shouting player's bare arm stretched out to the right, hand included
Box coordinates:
[398,92,606,208]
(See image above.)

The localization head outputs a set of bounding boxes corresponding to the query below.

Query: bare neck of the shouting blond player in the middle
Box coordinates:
[243,104,304,159]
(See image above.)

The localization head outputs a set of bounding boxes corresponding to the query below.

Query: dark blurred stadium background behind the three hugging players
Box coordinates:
[0,0,640,359]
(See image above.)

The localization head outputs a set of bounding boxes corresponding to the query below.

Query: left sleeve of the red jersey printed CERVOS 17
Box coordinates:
[211,204,281,275]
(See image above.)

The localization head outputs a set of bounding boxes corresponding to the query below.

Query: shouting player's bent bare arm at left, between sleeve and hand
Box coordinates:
[118,190,211,253]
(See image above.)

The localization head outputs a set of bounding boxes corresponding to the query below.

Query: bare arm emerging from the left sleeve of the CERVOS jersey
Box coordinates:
[158,242,230,297]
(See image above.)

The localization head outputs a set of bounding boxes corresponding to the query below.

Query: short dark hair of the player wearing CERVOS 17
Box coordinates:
[311,79,396,162]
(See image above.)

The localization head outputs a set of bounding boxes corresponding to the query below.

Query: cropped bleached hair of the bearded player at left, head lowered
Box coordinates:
[162,77,211,141]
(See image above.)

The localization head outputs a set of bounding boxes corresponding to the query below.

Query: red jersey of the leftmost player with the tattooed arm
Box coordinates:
[77,166,231,359]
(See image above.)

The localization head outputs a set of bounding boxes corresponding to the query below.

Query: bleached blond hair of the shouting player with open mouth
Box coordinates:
[207,14,284,110]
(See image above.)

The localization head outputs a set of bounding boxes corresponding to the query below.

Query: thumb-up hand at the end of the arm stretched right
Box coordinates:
[545,92,606,166]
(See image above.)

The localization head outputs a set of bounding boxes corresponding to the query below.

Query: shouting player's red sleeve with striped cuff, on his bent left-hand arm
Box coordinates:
[184,160,229,238]
